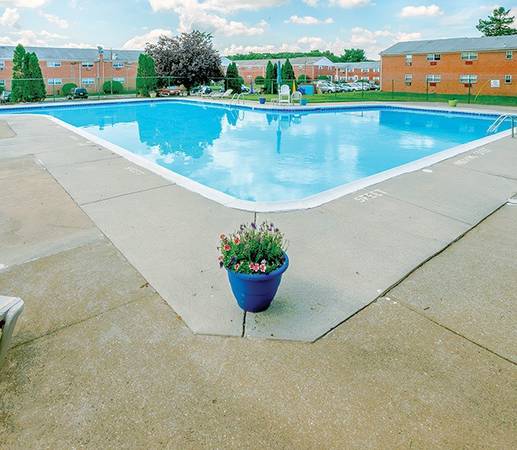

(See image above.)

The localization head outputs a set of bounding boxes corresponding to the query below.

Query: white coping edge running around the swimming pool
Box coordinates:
[4,98,511,213]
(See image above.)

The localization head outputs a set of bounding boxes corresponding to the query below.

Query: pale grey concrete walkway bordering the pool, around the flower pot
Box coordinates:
[0,104,517,341]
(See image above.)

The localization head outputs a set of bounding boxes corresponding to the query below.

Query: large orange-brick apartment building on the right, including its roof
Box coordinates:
[381,36,517,95]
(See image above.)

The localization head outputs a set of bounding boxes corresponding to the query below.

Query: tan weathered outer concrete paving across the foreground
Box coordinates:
[0,146,517,450]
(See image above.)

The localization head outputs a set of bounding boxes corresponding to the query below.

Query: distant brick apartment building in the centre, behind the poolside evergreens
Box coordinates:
[222,57,336,84]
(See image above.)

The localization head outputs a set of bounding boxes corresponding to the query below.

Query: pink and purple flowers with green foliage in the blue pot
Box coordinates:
[219,222,286,274]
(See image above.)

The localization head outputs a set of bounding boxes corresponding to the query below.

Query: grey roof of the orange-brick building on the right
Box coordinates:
[381,35,517,56]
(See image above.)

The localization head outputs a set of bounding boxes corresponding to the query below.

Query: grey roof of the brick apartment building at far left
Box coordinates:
[0,45,142,61]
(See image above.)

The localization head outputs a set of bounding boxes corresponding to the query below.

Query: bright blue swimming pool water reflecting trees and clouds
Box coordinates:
[3,101,504,201]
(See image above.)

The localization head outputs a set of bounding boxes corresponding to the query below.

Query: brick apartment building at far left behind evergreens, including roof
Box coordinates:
[0,46,141,95]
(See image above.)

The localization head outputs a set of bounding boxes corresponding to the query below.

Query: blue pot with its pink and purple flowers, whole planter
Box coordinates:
[218,222,289,313]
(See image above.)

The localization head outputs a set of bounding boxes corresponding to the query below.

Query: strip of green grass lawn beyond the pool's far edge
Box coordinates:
[242,91,517,106]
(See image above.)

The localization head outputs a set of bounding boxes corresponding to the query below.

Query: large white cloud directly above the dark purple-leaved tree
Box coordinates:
[145,0,268,36]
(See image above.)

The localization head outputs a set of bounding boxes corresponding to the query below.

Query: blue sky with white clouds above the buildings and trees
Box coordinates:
[0,0,510,59]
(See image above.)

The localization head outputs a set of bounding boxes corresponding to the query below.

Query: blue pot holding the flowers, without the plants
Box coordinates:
[227,254,289,312]
